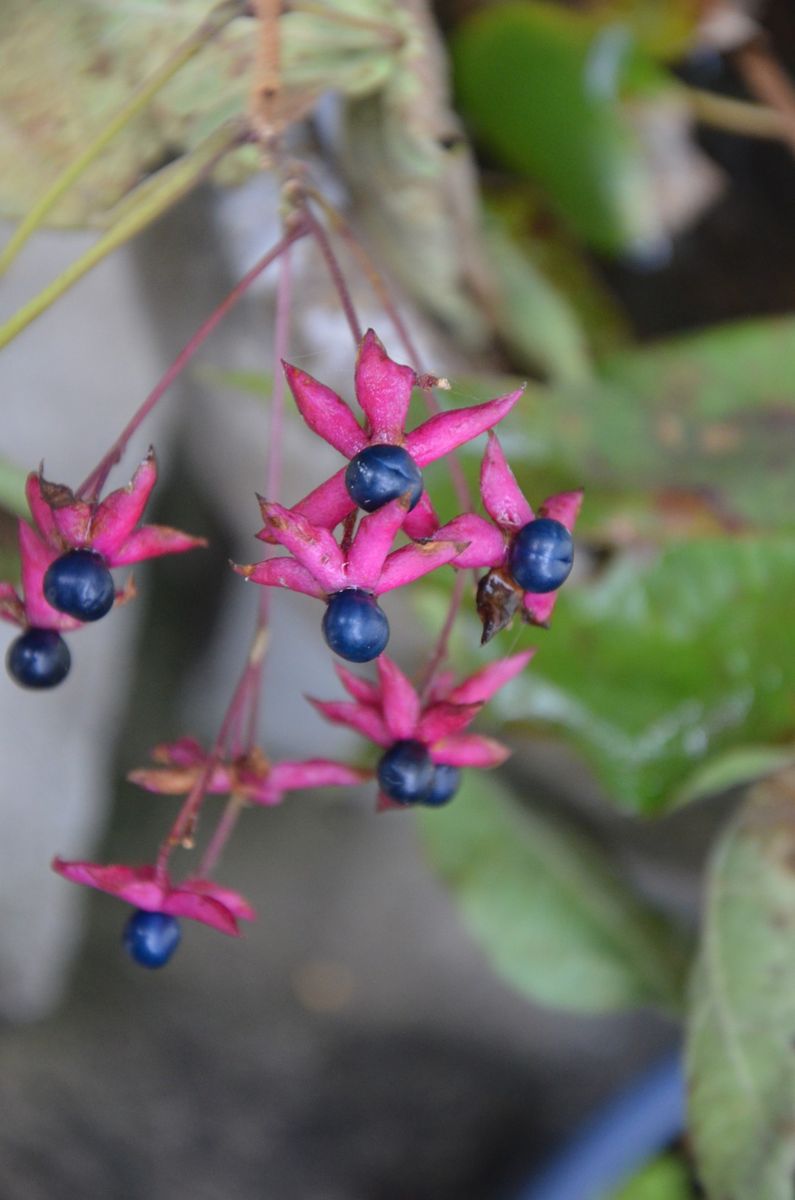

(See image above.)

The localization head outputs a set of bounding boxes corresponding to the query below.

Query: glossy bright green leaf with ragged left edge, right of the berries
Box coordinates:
[494,538,795,814]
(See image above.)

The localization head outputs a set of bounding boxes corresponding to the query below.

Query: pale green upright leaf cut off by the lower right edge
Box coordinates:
[687,770,795,1200]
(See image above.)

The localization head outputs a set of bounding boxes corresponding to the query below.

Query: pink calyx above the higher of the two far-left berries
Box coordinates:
[26,449,207,566]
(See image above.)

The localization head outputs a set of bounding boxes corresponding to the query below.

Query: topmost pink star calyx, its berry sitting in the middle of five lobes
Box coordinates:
[283,329,524,538]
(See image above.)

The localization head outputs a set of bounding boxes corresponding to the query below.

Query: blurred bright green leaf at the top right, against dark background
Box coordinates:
[453,0,663,253]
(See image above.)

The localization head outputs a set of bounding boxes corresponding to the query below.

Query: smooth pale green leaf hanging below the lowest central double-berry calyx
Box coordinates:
[420,770,683,1012]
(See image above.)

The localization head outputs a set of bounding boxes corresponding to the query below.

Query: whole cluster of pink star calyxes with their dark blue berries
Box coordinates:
[0,331,581,967]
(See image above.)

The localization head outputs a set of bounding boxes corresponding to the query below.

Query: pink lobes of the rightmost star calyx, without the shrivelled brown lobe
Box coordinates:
[435,432,582,640]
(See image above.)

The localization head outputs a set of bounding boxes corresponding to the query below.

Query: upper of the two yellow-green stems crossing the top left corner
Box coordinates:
[0,0,244,275]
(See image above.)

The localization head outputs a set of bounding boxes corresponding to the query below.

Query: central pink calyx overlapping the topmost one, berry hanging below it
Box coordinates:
[235,497,465,599]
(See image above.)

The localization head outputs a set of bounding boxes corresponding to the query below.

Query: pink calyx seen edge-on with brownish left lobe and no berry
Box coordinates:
[127,738,371,805]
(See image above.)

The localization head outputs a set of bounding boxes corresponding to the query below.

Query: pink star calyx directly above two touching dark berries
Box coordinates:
[310,649,534,810]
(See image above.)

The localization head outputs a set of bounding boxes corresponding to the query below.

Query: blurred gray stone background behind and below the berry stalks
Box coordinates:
[0,184,719,1200]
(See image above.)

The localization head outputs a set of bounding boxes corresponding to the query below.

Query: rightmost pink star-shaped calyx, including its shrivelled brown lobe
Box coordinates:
[434,432,582,642]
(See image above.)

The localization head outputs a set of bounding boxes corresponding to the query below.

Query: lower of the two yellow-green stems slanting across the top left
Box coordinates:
[0,121,245,349]
